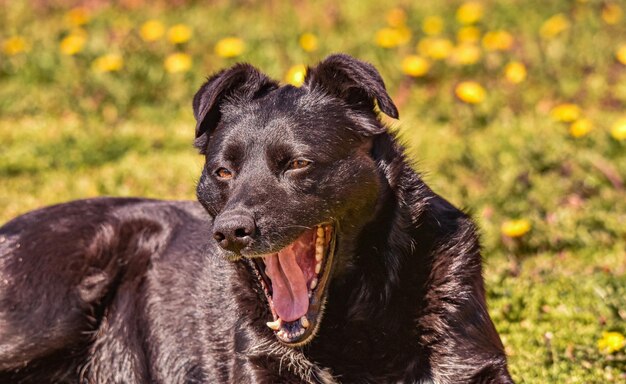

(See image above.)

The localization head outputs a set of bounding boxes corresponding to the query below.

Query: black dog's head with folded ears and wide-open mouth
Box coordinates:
[193,55,398,346]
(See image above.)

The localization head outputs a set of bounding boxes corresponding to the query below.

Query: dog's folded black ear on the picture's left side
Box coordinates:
[193,64,278,152]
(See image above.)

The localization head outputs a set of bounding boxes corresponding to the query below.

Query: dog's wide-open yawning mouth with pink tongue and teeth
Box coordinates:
[248,224,335,346]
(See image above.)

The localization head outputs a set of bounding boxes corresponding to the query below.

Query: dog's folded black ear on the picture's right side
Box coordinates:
[304,54,398,130]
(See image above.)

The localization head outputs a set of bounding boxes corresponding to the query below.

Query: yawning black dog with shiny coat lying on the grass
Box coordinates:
[0,55,512,383]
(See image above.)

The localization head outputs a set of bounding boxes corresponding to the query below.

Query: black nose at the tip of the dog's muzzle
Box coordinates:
[213,213,256,253]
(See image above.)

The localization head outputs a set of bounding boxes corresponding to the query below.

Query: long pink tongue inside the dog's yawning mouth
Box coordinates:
[264,246,309,321]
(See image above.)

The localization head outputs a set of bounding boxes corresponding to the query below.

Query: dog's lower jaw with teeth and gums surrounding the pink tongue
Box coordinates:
[246,224,337,347]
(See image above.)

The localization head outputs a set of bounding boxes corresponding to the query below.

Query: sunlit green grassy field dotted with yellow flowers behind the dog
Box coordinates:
[0,0,626,383]
